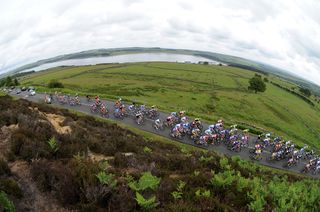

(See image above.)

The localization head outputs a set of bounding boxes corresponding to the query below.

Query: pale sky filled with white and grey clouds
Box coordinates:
[0,0,320,85]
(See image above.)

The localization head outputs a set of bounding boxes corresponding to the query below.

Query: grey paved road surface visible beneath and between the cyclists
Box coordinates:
[11,92,320,178]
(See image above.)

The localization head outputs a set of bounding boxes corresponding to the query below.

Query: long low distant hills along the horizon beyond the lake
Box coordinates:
[0,47,320,96]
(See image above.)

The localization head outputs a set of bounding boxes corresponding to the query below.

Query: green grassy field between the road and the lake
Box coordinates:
[21,62,320,149]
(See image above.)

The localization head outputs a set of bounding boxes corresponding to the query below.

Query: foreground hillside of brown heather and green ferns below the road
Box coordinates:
[0,97,320,211]
